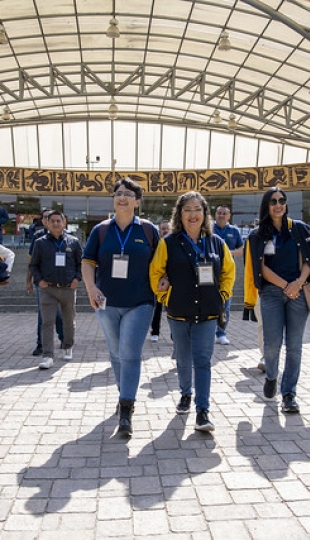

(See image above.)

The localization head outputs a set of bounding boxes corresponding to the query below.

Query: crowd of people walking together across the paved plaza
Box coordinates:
[0,184,310,436]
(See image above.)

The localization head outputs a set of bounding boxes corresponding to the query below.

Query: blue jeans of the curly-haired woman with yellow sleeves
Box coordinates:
[168,317,216,412]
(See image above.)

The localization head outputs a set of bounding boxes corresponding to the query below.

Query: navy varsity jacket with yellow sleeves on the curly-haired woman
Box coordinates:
[150,233,235,323]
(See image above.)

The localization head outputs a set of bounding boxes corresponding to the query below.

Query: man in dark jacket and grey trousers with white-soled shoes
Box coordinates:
[29,210,82,369]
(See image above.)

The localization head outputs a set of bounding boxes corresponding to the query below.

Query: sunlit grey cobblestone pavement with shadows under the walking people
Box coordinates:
[0,312,310,540]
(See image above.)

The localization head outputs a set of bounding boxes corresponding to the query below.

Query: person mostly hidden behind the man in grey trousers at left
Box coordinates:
[26,208,63,356]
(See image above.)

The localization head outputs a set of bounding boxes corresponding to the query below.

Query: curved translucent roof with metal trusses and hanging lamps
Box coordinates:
[0,0,310,148]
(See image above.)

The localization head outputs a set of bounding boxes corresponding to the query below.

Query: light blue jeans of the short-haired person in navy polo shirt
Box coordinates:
[96,304,154,401]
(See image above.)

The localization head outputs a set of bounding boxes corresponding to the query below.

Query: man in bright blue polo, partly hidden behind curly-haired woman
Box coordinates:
[213,205,243,345]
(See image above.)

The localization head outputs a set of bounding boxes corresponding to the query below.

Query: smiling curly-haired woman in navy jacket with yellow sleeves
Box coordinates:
[150,191,235,431]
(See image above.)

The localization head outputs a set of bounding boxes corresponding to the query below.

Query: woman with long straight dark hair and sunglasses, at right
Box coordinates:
[244,187,310,413]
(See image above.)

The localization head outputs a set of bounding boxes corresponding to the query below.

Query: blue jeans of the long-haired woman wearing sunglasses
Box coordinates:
[260,285,308,396]
